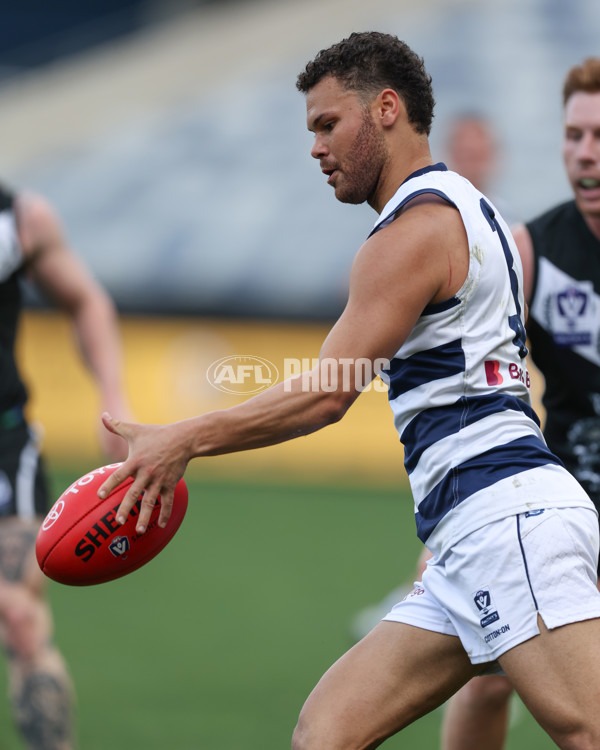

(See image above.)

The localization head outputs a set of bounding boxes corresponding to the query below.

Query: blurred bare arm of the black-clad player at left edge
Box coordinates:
[15,193,129,458]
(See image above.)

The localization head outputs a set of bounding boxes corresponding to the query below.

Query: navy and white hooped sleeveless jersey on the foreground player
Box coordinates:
[373,164,591,554]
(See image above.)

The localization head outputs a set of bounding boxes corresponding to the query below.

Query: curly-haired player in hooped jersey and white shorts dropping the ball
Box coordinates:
[99,32,600,750]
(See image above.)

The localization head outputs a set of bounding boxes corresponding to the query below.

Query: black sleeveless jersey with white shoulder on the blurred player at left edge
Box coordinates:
[0,187,27,414]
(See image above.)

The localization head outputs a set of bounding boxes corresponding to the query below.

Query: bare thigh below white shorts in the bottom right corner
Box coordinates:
[499,618,600,750]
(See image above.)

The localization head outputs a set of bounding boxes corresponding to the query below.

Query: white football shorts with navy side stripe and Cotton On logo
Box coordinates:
[383,506,600,673]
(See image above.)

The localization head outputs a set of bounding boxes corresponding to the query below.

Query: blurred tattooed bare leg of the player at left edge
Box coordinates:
[0,518,74,750]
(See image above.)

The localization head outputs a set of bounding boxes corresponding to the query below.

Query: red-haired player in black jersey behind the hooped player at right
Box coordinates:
[442,58,600,750]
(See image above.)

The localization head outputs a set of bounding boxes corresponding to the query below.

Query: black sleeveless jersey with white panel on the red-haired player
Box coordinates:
[526,201,600,500]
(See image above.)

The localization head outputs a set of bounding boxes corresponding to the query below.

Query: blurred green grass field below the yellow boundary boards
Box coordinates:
[0,472,555,750]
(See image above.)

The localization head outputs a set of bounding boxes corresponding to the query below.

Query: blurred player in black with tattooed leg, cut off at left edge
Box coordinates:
[0,187,128,750]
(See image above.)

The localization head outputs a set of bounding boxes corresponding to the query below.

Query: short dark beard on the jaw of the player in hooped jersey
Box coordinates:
[335,111,389,205]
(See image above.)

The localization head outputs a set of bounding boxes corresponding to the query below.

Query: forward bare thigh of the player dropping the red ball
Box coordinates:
[294,622,478,750]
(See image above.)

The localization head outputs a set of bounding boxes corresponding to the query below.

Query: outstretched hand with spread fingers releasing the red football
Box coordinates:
[98,412,189,534]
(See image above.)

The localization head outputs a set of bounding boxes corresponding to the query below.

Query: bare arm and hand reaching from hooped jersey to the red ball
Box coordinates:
[100,197,468,531]
